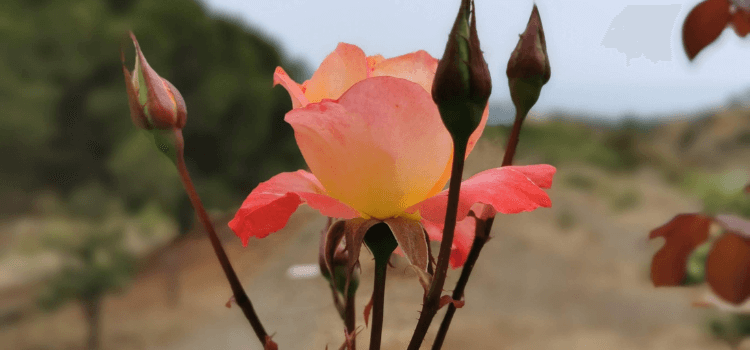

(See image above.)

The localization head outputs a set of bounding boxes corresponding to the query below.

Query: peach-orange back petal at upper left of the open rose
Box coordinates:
[304,43,367,102]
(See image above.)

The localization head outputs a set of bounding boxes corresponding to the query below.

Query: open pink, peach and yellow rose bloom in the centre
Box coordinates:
[229,43,555,267]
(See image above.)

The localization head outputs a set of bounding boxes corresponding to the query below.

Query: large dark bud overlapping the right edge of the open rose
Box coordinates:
[432,0,492,140]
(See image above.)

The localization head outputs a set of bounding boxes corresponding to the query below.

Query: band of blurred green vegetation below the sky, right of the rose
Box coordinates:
[485,105,750,217]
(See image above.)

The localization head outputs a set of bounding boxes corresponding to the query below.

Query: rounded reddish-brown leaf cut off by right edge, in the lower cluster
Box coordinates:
[706,232,750,305]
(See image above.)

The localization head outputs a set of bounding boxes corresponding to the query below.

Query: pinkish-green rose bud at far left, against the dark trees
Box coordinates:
[121,32,187,130]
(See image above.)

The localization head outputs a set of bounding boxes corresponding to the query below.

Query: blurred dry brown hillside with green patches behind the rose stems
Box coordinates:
[0,109,750,350]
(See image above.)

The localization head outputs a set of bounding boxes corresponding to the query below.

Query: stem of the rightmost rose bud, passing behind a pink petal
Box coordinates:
[432,110,526,350]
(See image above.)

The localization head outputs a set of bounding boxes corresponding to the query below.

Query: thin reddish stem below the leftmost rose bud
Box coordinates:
[174,129,268,346]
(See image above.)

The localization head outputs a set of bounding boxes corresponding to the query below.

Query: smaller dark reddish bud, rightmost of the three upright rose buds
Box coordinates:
[505,5,551,118]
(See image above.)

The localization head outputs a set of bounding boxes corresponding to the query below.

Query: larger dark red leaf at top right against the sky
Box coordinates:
[682,0,731,61]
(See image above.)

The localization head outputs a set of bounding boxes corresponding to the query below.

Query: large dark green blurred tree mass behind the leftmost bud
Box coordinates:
[0,0,303,216]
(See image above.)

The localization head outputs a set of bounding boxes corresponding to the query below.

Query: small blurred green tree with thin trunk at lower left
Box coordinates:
[40,184,136,350]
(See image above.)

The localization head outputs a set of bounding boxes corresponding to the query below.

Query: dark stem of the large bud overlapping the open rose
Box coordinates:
[407,139,467,350]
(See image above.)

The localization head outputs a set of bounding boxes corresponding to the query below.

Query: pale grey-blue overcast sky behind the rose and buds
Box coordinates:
[198,0,750,118]
